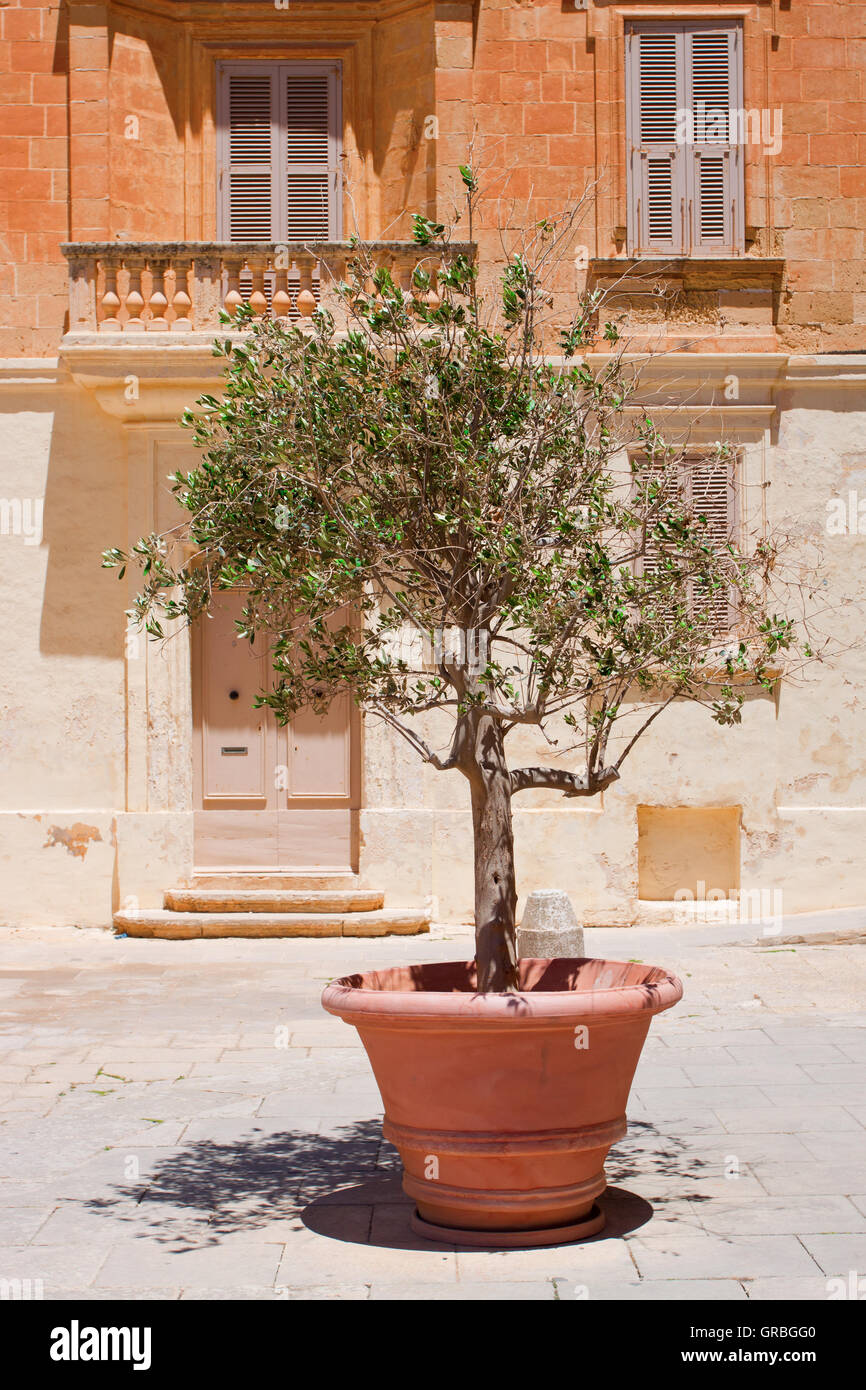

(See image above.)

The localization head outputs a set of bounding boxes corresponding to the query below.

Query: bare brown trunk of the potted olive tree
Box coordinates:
[467,714,518,994]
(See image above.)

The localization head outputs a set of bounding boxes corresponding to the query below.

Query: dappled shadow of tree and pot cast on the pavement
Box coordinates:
[83,1119,706,1252]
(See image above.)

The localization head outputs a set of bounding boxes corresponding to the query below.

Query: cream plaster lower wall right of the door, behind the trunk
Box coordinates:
[361,372,866,924]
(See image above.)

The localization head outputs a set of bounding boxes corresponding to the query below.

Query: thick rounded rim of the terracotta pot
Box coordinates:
[321,956,683,1027]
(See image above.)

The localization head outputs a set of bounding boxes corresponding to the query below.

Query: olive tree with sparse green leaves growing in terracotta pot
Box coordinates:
[104,179,798,991]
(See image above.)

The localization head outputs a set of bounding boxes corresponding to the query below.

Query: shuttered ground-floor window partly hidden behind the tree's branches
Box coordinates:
[635,455,740,637]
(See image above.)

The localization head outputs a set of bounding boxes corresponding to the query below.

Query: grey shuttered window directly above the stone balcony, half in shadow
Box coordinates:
[217,63,342,243]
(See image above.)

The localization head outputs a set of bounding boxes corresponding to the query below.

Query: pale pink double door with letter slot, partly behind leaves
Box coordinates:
[193,594,359,870]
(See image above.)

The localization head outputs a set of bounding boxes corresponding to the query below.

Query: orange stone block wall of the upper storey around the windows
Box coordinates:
[0,0,866,356]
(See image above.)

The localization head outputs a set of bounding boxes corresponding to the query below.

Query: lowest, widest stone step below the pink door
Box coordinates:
[114,908,430,940]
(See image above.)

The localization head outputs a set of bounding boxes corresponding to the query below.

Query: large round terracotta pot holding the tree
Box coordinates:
[322,960,683,1245]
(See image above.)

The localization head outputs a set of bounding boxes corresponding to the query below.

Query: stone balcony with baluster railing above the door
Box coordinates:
[60,242,474,423]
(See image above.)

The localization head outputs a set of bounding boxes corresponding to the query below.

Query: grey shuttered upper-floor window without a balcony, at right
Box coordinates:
[626,19,748,256]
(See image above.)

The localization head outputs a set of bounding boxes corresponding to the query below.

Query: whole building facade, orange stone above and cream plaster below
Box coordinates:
[0,0,866,927]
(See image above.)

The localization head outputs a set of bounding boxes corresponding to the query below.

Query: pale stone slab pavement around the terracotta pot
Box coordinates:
[0,927,866,1301]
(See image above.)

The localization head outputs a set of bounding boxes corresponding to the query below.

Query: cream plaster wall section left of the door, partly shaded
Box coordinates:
[0,363,126,926]
